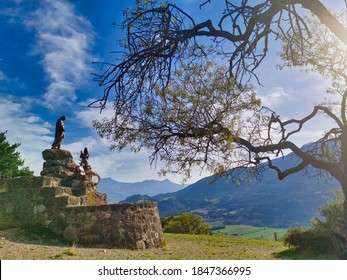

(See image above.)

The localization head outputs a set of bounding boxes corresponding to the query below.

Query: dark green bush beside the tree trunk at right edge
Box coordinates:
[284,193,344,254]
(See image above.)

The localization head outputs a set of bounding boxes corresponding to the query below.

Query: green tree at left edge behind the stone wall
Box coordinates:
[0,132,34,177]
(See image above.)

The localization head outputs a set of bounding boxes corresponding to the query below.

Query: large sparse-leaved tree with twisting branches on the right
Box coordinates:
[91,0,347,258]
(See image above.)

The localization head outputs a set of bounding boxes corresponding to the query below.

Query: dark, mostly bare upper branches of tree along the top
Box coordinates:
[93,0,347,108]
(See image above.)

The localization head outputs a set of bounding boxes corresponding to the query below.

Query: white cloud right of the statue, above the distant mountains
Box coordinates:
[67,103,204,183]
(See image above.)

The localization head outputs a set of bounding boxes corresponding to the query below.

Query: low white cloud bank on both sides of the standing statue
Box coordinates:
[0,95,185,182]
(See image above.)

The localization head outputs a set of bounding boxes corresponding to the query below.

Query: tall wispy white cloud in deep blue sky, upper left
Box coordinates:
[24,0,94,109]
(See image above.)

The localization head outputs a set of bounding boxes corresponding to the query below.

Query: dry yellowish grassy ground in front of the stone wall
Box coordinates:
[0,229,337,260]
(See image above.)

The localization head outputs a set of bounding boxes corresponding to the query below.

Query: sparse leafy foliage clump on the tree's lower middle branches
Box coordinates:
[94,61,267,180]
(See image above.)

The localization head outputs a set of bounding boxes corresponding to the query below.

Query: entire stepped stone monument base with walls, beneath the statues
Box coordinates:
[0,150,163,249]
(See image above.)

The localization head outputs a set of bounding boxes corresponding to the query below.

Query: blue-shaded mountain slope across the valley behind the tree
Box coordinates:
[121,151,339,228]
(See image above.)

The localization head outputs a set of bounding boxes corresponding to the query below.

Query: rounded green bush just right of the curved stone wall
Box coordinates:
[163,212,211,234]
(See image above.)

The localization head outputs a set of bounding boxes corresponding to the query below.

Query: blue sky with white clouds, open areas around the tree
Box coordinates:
[0,0,344,182]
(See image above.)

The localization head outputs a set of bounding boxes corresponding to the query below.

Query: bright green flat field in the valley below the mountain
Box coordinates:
[213,225,287,240]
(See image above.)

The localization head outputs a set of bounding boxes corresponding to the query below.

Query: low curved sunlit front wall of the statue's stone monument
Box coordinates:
[64,202,163,249]
